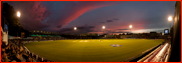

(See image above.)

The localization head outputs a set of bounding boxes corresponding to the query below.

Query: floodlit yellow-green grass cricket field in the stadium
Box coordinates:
[25,39,164,62]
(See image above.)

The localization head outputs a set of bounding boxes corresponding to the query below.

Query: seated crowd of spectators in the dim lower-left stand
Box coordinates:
[1,40,50,62]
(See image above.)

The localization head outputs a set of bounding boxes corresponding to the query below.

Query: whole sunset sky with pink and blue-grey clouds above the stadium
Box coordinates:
[7,1,176,34]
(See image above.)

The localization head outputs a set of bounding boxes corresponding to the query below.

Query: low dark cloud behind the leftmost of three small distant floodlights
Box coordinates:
[59,25,95,34]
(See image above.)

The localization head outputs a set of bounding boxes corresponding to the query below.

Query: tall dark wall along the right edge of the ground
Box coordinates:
[169,1,181,62]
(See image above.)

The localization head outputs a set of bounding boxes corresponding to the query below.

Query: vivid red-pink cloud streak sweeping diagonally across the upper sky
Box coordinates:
[54,2,120,30]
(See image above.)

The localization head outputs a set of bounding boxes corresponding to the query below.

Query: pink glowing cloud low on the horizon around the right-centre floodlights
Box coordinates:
[90,19,146,33]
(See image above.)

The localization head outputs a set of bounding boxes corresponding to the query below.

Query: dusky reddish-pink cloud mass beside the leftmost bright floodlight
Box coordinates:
[15,1,51,31]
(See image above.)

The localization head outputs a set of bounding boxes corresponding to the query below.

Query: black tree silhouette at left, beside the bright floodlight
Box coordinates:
[1,2,29,36]
